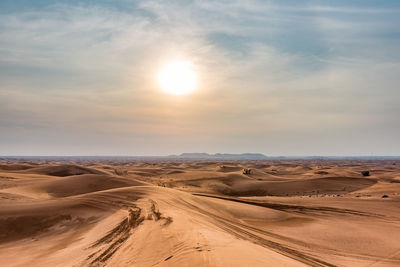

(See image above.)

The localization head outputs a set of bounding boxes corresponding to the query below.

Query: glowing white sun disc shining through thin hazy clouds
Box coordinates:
[157,61,197,95]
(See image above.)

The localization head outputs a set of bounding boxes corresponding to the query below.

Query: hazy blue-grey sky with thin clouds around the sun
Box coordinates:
[0,0,400,156]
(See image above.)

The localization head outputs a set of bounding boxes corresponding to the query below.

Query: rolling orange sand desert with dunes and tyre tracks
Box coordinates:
[0,159,400,266]
